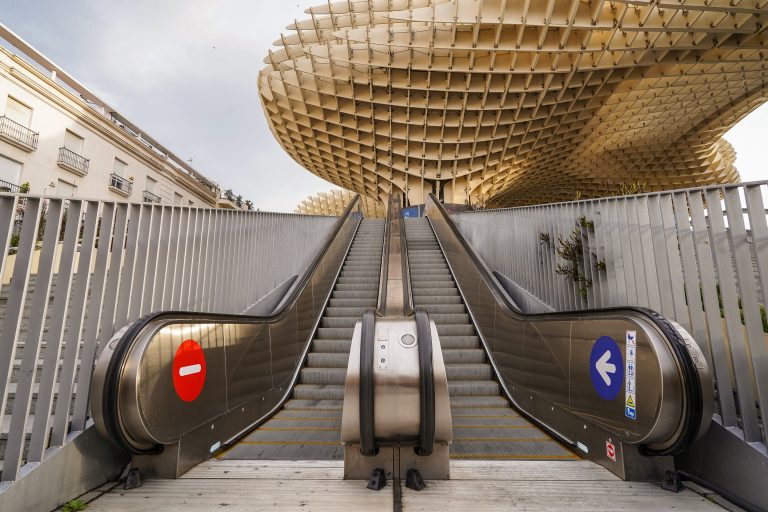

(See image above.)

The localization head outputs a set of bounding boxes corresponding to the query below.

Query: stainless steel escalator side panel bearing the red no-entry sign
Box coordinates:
[91,198,361,468]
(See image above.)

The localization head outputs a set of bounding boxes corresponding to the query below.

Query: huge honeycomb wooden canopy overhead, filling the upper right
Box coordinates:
[259,0,768,206]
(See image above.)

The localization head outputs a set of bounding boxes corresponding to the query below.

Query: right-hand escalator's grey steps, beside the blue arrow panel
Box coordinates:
[405,218,578,460]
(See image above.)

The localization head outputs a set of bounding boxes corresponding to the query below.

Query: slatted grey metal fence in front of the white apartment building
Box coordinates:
[0,195,336,481]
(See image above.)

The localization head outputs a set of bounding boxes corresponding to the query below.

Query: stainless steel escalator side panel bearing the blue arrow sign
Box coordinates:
[427,195,712,456]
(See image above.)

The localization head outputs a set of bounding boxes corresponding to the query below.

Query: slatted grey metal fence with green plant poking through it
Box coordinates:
[453,182,768,453]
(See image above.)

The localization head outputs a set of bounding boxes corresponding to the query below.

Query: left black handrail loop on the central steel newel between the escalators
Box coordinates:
[360,310,377,455]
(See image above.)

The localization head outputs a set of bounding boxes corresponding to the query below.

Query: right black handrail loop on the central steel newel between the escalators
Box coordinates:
[416,309,435,455]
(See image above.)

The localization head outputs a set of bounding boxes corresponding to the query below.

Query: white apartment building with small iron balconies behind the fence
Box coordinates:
[0,24,225,207]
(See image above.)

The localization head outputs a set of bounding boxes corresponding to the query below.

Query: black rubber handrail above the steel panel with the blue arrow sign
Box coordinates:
[425,194,704,455]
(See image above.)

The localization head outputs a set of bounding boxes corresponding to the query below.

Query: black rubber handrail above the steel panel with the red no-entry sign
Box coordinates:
[101,194,360,453]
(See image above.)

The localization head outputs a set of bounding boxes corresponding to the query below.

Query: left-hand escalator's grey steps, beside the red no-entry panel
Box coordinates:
[219,219,384,460]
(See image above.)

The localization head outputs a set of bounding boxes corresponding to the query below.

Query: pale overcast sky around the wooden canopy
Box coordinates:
[0,0,768,211]
